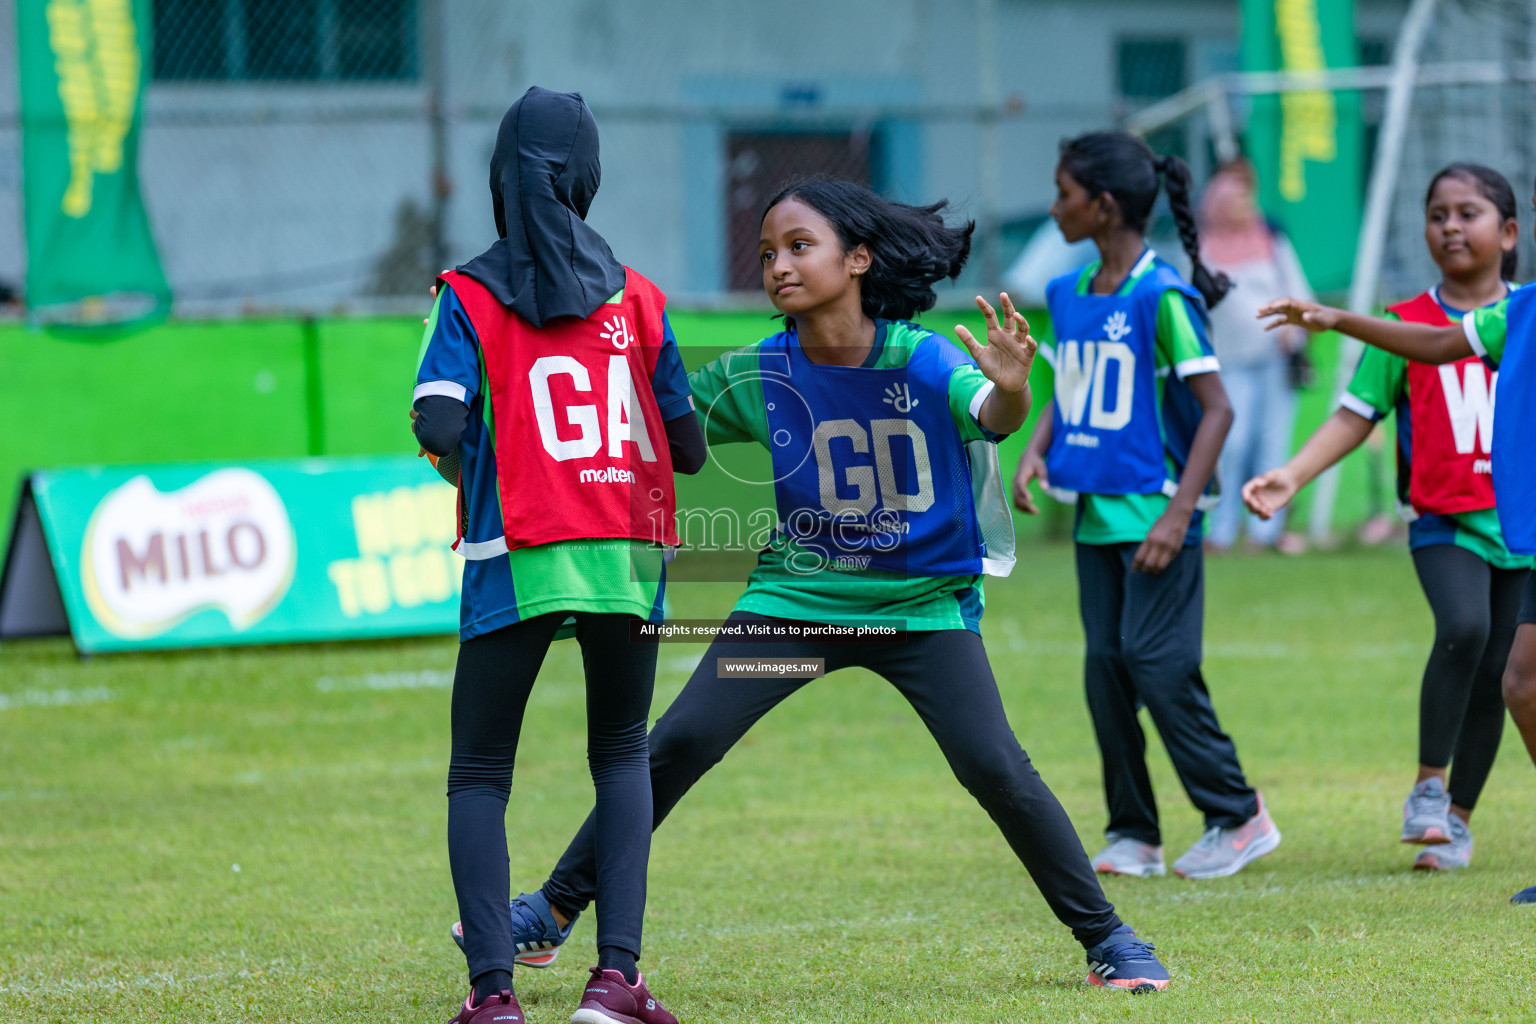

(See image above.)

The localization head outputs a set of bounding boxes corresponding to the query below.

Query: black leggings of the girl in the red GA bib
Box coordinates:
[449,613,656,979]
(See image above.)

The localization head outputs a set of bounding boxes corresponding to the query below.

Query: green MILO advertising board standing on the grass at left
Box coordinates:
[0,456,462,651]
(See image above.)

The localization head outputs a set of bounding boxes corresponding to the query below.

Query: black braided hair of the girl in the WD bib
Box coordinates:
[1061,132,1232,309]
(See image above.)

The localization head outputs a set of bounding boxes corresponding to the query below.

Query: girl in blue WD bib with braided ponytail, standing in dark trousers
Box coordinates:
[1014,132,1279,878]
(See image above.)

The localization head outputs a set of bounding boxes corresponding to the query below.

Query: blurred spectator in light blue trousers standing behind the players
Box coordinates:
[1200,160,1312,554]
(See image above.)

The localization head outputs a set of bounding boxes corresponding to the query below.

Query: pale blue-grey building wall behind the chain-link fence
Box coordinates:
[0,0,1404,313]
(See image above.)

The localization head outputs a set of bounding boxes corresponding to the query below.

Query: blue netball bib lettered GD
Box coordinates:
[759,332,1012,576]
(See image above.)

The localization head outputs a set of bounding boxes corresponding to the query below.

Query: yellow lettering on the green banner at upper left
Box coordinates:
[48,0,141,218]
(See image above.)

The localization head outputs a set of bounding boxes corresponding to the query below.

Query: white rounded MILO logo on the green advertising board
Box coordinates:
[81,468,295,639]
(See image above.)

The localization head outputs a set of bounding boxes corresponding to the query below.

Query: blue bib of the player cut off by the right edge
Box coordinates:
[1491,286,1536,554]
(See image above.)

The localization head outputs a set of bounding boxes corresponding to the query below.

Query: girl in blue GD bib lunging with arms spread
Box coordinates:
[454,180,1169,992]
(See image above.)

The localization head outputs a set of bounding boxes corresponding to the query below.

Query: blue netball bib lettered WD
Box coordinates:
[1046,254,1203,497]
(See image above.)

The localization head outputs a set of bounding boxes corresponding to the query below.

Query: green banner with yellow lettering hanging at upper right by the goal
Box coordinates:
[1243,0,1362,290]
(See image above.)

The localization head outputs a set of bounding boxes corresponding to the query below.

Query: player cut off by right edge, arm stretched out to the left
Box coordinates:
[1260,174,1536,904]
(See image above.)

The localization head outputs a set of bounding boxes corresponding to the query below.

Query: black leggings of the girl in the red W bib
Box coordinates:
[1413,543,1528,811]
